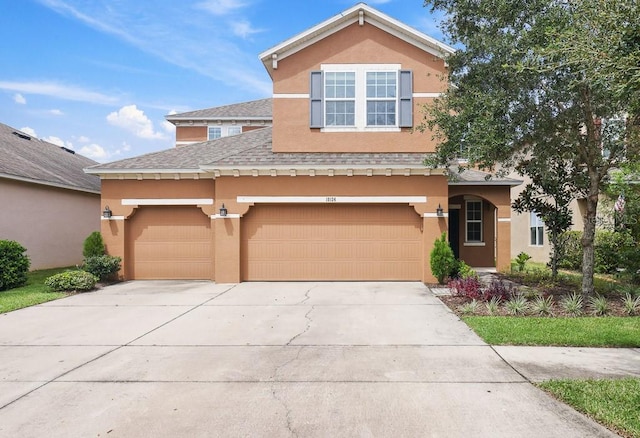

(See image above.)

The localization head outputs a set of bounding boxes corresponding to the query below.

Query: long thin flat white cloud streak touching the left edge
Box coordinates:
[0,81,118,105]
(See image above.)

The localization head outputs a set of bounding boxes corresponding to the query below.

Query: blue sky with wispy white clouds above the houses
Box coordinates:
[0,0,443,162]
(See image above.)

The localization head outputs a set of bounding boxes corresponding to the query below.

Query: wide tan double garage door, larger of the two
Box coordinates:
[242,204,422,281]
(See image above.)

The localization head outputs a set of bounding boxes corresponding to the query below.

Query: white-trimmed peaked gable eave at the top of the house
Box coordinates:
[259,3,455,70]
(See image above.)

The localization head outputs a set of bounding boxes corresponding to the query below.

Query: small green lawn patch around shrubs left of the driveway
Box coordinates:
[0,267,74,313]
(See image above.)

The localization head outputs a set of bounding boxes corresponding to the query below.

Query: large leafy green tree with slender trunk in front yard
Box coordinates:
[425,0,640,296]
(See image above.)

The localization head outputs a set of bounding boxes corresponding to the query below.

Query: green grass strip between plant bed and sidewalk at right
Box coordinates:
[463,316,640,348]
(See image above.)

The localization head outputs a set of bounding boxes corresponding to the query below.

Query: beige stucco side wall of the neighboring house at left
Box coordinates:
[0,179,101,269]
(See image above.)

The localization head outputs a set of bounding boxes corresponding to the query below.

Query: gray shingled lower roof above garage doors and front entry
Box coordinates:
[85,127,520,185]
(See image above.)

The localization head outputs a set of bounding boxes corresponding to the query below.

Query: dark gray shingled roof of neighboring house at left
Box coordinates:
[0,123,100,193]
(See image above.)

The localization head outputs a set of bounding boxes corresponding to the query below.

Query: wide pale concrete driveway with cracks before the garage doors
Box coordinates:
[0,281,615,438]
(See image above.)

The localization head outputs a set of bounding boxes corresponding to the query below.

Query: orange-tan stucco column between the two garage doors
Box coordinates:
[213,216,241,283]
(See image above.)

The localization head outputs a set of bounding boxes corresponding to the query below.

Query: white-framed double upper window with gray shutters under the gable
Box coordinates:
[310,64,413,131]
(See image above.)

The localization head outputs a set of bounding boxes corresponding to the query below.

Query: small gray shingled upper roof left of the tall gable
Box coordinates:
[166,98,273,122]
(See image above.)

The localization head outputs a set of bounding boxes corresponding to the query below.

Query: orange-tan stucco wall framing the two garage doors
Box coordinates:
[102,176,447,283]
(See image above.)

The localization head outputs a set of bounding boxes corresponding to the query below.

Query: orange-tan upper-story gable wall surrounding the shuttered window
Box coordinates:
[267,23,446,152]
